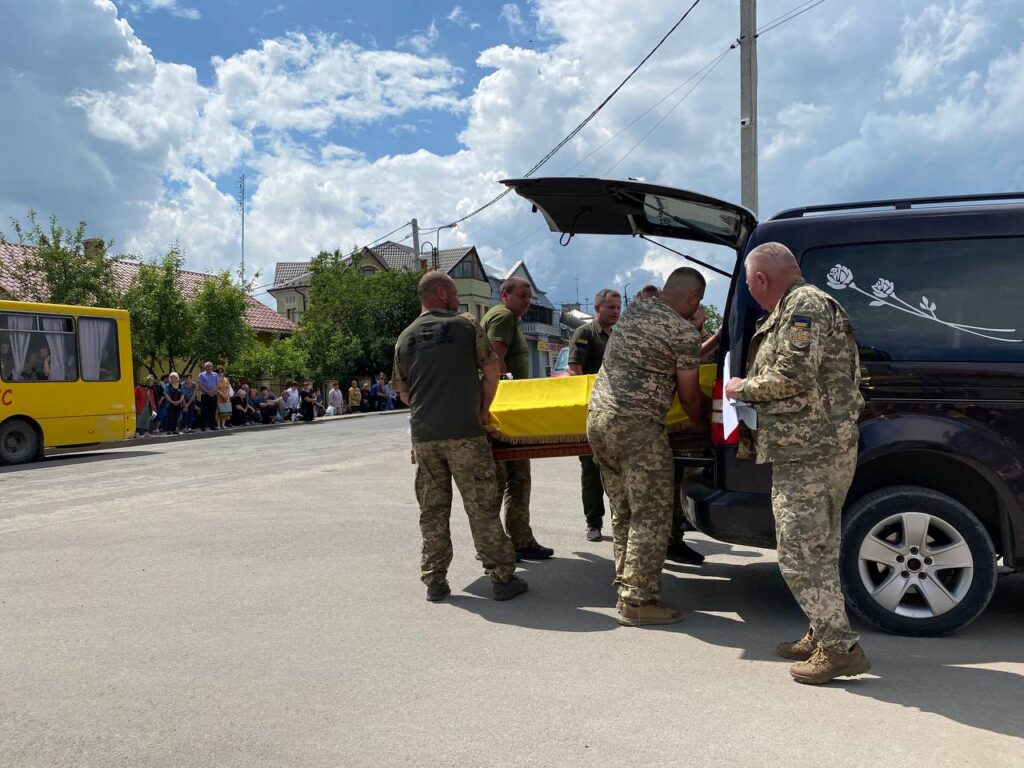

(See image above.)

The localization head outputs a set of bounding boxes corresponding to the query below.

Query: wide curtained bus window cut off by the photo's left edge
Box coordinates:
[0,312,78,381]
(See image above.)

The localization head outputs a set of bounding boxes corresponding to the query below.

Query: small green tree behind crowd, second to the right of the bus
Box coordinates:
[192,272,253,371]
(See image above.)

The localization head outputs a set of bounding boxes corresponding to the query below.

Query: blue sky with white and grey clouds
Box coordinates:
[0,0,1024,313]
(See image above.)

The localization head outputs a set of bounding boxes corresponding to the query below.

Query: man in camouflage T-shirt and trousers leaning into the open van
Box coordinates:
[587,267,705,627]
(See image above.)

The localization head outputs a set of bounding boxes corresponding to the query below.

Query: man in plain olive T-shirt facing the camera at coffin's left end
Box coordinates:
[480,278,555,560]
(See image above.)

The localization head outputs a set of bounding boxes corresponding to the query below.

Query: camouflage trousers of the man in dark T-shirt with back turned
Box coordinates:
[413,436,515,585]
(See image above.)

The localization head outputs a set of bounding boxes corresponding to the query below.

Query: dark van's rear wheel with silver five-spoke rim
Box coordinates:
[841,485,996,636]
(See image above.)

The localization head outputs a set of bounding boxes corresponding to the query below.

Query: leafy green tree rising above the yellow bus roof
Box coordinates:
[3,210,120,306]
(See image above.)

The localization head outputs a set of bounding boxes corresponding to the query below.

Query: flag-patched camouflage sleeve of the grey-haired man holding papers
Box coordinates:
[736,294,831,402]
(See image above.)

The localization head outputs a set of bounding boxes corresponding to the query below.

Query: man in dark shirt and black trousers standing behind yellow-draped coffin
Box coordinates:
[569,288,623,542]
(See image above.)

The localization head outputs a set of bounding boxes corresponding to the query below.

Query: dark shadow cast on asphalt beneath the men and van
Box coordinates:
[450,541,1024,737]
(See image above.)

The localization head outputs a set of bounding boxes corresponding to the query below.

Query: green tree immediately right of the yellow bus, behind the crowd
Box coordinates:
[123,248,196,377]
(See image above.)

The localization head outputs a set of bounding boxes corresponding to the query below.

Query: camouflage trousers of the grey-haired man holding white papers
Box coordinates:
[771,445,858,651]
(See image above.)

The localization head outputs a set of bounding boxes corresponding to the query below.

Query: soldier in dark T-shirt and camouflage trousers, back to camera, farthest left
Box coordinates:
[392,271,526,602]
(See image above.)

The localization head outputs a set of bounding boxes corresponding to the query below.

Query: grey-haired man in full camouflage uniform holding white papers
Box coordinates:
[725,243,869,684]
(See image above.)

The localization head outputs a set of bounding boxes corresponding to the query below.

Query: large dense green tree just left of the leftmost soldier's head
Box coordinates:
[297,251,421,381]
